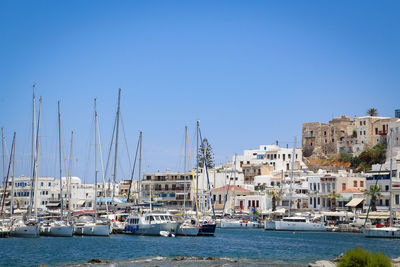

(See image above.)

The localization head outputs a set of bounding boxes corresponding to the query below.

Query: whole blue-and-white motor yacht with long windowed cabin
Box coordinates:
[124,212,181,236]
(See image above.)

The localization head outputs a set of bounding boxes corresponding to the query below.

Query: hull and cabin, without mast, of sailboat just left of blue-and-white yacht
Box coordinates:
[74,215,111,236]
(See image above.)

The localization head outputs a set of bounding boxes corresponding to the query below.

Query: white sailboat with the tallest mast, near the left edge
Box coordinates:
[11,85,42,237]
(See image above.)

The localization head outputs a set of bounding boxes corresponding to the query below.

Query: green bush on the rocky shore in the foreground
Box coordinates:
[338,248,392,267]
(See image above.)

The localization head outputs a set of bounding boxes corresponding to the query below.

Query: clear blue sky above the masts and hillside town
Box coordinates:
[0,0,400,181]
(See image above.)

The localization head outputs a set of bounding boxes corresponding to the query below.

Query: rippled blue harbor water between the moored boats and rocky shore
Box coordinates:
[0,229,400,266]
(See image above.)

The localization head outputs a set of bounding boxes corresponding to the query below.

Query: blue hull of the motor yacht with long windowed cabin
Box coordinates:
[124,222,179,236]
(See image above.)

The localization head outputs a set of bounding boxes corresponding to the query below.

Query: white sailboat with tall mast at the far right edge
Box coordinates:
[363,129,400,238]
